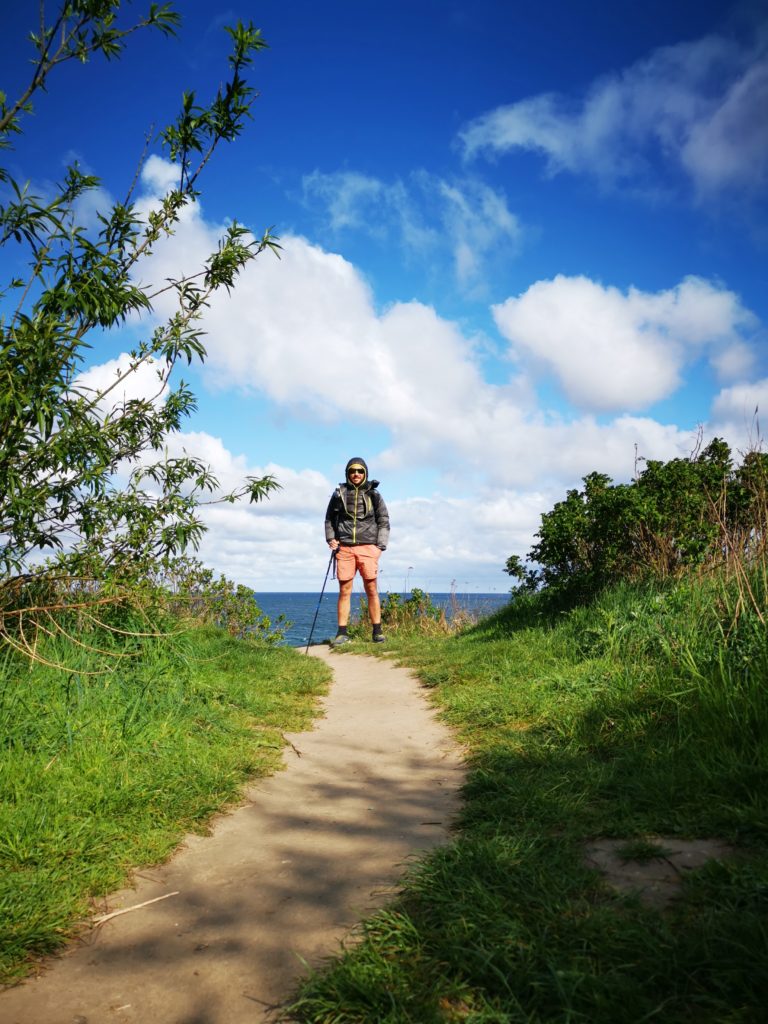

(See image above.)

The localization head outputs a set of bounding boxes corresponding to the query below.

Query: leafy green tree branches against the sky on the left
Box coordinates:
[0,0,279,604]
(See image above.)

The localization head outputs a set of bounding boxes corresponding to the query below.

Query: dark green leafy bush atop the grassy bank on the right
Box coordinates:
[506,437,768,602]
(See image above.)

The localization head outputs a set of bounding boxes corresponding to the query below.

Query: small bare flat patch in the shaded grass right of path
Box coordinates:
[584,836,736,910]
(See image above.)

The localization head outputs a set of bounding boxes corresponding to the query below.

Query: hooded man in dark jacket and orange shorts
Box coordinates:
[326,459,389,647]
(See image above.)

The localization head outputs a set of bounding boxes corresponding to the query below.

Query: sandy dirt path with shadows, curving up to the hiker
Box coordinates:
[0,647,463,1024]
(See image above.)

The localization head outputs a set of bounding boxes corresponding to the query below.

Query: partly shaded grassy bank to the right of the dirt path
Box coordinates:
[291,579,768,1024]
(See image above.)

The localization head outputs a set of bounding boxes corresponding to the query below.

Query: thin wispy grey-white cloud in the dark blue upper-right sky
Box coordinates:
[460,33,768,196]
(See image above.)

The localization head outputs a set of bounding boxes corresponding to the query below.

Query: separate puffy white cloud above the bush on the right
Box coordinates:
[494,275,756,412]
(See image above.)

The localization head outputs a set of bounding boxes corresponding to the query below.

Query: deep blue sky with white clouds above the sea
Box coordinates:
[0,0,768,592]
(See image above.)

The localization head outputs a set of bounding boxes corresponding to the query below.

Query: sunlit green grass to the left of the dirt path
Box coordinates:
[0,630,329,983]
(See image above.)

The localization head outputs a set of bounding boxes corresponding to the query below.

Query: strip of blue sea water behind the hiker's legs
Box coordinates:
[255,591,509,647]
